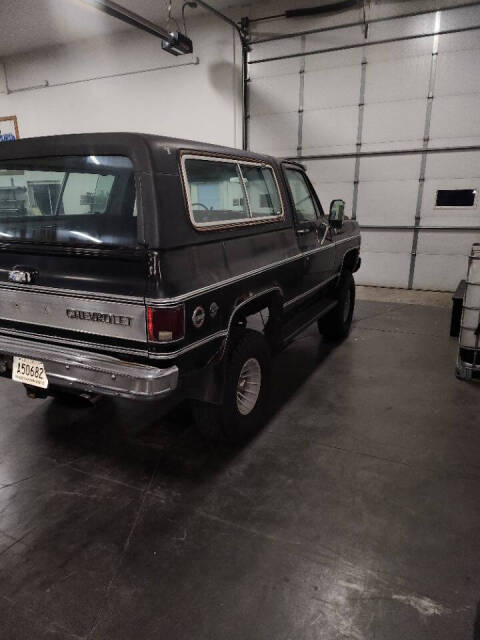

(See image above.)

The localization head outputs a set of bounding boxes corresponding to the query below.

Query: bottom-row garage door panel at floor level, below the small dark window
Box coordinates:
[413,254,468,291]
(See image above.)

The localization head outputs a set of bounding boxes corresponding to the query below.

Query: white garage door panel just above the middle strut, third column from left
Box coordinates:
[363,100,426,148]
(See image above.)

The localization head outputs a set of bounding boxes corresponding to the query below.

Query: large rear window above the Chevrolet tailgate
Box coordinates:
[0,156,137,247]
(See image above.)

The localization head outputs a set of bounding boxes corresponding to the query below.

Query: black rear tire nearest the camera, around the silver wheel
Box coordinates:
[192,329,271,444]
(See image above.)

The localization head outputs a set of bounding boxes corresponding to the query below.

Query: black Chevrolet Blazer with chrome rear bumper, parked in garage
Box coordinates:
[0,133,360,440]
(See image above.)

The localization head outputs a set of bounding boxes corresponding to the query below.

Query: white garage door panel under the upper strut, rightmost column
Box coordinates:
[435,50,480,97]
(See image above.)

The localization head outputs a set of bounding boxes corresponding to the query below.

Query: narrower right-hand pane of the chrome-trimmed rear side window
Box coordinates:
[240,164,282,218]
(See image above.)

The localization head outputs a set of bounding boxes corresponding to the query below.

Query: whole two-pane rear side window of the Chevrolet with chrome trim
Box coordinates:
[183,156,282,227]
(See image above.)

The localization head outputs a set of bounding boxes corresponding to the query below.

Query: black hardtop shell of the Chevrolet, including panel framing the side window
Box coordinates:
[0,133,291,249]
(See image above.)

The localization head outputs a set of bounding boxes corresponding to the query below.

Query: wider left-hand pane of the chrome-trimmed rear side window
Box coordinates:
[185,158,249,226]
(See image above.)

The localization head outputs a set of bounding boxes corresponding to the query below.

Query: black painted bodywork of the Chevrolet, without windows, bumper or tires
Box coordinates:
[0,133,360,401]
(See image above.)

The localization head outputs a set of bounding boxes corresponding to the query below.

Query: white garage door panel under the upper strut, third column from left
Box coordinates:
[365,55,431,103]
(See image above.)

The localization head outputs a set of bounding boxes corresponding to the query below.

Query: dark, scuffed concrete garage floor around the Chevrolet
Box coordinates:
[0,300,480,640]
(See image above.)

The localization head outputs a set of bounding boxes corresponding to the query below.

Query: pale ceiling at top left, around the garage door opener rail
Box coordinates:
[0,0,252,57]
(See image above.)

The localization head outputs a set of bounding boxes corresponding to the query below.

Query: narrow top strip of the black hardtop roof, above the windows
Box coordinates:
[0,132,276,171]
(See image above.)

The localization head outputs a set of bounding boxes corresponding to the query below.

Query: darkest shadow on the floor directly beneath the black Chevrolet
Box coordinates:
[44,341,335,479]
